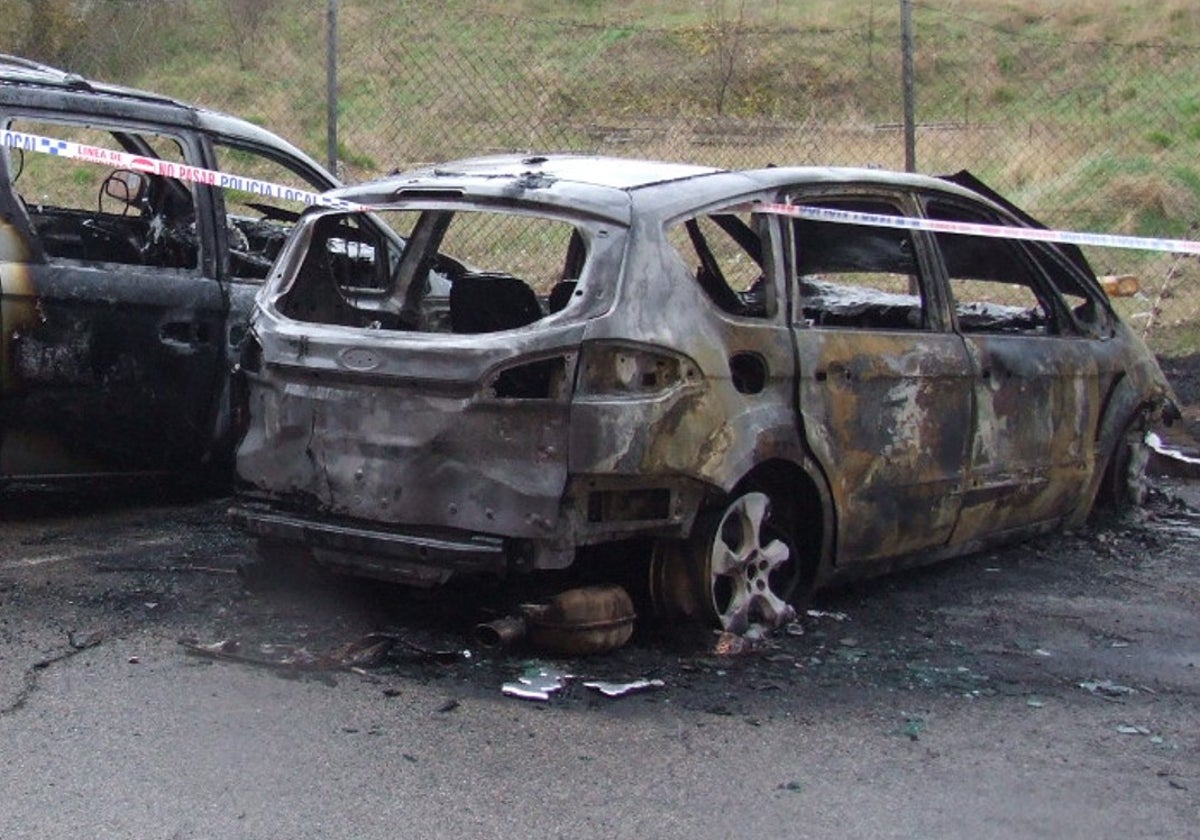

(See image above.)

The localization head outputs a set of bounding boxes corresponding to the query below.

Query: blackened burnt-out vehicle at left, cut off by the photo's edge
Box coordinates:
[0,56,337,482]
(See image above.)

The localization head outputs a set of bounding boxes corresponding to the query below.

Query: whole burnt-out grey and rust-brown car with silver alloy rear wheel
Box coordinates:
[233,155,1175,631]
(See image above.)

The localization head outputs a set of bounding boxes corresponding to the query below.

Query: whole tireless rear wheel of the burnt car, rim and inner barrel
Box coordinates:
[650,490,803,635]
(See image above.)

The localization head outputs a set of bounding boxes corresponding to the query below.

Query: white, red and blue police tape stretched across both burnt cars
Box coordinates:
[0,131,1200,254]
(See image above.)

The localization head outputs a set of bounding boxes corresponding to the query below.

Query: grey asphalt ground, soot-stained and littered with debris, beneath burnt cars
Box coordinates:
[0,481,1200,840]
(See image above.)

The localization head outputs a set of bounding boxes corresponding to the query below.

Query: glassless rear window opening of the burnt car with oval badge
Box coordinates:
[280,210,600,334]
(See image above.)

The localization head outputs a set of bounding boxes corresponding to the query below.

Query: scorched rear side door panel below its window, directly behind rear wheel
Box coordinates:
[797,330,972,564]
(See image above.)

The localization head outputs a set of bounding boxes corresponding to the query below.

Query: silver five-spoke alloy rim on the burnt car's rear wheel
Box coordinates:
[706,492,797,634]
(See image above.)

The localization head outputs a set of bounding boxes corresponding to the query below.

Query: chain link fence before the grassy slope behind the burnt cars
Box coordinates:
[7,0,1200,353]
